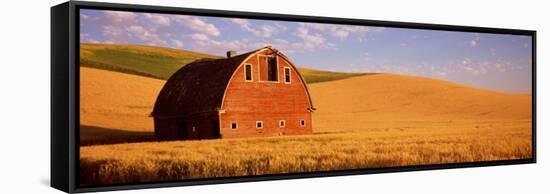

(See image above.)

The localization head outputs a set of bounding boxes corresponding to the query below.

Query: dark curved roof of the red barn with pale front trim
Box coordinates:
[151,47,313,118]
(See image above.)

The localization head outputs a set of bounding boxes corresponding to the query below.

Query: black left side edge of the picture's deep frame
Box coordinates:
[50,2,71,192]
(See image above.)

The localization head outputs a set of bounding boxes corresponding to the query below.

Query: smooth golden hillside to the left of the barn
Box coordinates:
[80,67,165,132]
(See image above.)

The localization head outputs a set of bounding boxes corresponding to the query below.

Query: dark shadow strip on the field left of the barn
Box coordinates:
[80,125,157,146]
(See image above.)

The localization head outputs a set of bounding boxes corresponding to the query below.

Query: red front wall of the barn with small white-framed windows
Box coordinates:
[220,49,312,138]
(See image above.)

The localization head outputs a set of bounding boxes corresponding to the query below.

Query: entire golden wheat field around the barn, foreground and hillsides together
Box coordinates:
[80,67,532,185]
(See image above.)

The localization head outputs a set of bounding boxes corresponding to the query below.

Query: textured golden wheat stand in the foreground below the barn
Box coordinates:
[80,121,531,185]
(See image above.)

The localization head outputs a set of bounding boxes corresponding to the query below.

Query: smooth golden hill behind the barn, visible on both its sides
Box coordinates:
[80,67,531,136]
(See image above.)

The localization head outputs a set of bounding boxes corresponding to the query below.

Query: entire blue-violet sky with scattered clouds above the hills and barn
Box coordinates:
[80,10,532,93]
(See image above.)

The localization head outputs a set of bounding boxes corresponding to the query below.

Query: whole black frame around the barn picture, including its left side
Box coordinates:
[51,1,537,193]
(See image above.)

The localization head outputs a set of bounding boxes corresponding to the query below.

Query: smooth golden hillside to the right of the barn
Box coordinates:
[309,74,531,131]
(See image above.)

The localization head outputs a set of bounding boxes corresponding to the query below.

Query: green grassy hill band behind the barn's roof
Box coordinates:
[80,44,374,83]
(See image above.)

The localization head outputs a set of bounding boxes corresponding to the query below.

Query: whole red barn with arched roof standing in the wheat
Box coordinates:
[151,47,315,139]
